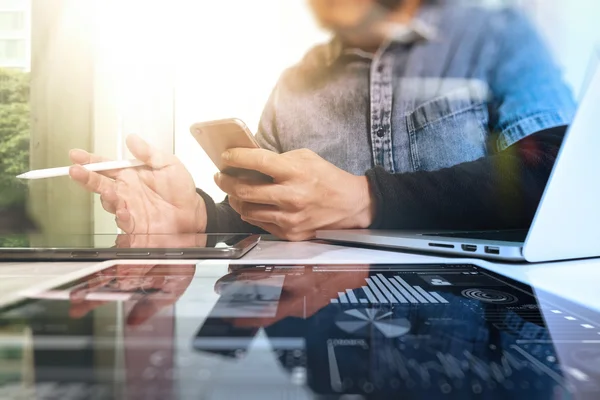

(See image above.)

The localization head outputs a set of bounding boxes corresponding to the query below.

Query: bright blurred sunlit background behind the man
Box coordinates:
[0,0,600,238]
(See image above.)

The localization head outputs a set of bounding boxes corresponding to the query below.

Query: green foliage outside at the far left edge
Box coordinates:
[0,69,30,207]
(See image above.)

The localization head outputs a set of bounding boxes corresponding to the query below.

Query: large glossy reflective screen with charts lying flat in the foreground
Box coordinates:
[0,264,600,399]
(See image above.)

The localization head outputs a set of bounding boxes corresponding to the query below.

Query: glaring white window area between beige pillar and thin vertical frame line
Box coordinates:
[90,0,177,233]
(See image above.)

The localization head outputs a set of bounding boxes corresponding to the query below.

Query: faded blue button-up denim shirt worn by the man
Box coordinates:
[257,2,575,175]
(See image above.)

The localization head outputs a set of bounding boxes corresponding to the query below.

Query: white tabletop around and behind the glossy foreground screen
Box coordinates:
[0,242,600,311]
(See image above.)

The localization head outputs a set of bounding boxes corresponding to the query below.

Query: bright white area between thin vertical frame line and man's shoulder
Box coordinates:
[170,0,327,199]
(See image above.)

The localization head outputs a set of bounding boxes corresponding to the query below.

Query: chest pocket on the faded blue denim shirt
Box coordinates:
[406,87,489,171]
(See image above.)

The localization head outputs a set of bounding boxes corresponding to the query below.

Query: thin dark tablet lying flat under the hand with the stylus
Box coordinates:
[0,234,260,261]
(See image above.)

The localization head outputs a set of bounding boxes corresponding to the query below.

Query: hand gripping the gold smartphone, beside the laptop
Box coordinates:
[215,149,375,241]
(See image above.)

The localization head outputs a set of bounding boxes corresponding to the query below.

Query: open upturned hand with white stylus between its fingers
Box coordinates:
[69,135,207,234]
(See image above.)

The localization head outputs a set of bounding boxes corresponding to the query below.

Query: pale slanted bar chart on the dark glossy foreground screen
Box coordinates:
[331,274,448,305]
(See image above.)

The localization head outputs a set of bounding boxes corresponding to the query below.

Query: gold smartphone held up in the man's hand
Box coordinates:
[190,118,272,180]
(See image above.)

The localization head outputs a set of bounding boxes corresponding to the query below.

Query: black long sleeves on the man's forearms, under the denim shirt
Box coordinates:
[198,126,566,233]
